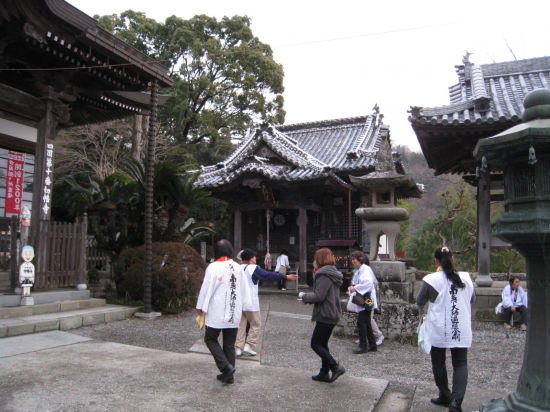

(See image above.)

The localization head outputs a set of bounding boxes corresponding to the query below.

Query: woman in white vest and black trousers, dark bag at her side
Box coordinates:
[348,251,378,354]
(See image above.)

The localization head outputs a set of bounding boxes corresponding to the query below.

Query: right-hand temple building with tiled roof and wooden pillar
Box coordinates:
[409,53,550,286]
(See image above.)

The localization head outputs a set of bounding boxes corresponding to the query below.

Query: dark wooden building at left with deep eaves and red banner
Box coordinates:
[0,0,172,289]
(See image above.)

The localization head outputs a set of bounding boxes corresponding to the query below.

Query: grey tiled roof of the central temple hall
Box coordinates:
[195,114,388,189]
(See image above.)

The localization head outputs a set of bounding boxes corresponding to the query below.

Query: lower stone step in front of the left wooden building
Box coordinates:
[0,306,140,338]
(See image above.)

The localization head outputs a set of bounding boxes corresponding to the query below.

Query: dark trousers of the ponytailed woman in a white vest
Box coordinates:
[430,346,468,401]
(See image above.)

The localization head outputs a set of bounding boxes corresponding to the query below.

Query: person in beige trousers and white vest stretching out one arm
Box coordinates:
[235,249,296,356]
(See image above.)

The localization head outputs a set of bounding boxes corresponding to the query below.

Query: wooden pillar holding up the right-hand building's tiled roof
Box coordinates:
[476,170,493,287]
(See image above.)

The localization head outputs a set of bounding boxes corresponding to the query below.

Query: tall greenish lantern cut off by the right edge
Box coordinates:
[474,89,550,412]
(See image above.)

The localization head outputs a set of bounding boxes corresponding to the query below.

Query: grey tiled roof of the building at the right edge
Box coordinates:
[409,56,550,126]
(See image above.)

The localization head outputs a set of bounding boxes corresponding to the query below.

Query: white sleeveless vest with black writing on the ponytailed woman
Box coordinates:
[424,271,474,348]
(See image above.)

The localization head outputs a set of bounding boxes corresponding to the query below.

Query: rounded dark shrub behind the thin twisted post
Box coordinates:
[114,242,206,313]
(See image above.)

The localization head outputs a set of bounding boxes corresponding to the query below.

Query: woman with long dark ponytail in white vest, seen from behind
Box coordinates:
[416,247,475,412]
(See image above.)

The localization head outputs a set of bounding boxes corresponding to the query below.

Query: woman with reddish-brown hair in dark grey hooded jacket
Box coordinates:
[298,248,346,383]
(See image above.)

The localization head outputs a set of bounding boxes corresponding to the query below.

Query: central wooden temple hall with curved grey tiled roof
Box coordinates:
[196,110,421,283]
